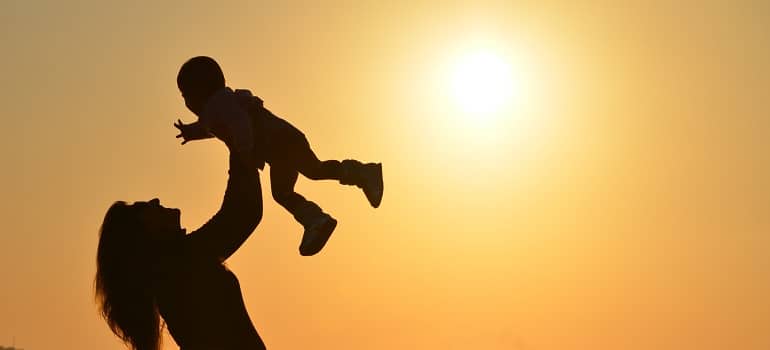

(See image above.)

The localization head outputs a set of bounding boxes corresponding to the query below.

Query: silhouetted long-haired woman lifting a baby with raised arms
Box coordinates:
[96,152,265,350]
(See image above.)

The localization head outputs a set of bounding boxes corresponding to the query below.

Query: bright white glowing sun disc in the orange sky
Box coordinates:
[451,51,515,117]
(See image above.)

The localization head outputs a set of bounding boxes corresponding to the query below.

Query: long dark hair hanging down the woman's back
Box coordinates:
[95,202,162,350]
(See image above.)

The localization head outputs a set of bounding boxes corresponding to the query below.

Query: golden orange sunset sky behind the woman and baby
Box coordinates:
[0,0,770,350]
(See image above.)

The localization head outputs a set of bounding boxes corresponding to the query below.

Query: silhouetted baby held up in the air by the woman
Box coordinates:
[174,56,383,256]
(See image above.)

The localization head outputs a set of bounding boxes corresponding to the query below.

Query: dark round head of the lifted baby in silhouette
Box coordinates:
[176,56,225,116]
